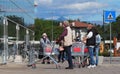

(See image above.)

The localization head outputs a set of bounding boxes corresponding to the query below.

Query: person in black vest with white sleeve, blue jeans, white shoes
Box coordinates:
[84,25,96,68]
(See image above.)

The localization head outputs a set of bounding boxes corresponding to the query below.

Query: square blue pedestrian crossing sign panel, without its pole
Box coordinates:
[104,11,116,22]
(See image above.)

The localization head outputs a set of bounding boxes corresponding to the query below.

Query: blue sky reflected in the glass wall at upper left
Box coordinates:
[0,0,34,25]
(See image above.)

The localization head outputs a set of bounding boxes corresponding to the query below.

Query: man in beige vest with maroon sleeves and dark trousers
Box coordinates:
[59,21,73,69]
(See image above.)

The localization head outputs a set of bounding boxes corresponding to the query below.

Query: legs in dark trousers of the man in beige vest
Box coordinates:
[65,46,73,69]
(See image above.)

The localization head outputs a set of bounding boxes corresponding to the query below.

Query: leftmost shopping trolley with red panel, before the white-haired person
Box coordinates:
[37,43,60,68]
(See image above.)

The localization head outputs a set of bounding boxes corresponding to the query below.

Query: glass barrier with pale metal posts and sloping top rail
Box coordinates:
[0,17,34,64]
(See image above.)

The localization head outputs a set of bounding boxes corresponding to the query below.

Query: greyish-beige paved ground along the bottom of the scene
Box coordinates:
[0,62,120,74]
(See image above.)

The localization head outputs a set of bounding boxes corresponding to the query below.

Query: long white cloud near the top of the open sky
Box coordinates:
[58,2,105,10]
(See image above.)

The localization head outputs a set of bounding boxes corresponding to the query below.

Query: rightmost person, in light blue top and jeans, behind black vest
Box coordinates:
[94,28,101,66]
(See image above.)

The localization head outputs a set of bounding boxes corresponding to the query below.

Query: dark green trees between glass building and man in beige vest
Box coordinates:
[34,18,62,40]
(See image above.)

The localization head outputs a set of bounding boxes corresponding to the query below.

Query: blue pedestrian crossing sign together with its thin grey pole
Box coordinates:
[104,11,116,64]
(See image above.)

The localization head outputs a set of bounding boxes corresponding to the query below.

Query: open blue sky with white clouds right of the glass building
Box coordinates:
[35,0,120,21]
